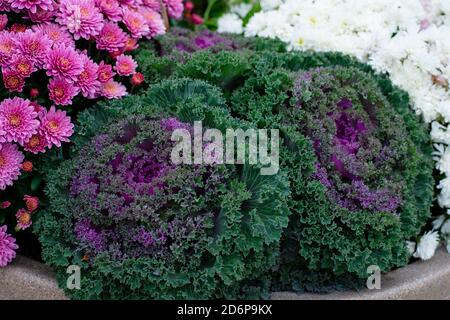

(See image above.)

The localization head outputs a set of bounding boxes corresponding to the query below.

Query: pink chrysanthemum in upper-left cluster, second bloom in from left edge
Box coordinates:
[15,29,52,67]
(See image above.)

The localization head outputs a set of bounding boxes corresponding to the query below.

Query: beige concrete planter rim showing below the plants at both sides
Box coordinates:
[0,249,450,300]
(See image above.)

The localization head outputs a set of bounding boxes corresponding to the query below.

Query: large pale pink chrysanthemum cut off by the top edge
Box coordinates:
[56,0,103,40]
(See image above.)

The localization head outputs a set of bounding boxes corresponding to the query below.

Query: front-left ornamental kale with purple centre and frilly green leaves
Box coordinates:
[36,86,290,299]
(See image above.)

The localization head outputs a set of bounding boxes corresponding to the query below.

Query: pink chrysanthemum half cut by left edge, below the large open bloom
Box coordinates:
[0,143,25,190]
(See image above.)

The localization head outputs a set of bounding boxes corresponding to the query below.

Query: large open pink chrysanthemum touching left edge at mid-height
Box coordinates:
[0,97,39,145]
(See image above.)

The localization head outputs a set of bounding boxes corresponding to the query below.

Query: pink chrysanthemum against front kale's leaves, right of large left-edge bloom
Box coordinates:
[39,106,73,148]
